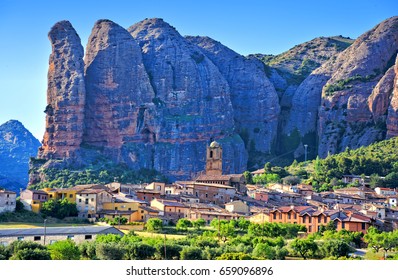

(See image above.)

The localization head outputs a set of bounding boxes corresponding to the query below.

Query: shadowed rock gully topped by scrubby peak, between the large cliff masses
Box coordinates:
[256,36,354,157]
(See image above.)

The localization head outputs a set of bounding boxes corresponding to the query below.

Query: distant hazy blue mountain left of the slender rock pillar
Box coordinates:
[0,120,40,194]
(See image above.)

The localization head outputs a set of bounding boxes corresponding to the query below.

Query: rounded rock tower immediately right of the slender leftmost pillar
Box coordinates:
[84,20,154,154]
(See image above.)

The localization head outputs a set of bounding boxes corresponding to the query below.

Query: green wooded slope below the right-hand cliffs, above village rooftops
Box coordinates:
[252,137,398,191]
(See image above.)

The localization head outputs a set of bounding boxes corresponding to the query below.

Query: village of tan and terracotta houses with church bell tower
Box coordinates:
[0,141,398,245]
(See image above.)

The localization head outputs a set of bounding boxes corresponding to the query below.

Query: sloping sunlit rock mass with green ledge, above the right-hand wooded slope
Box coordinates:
[318,17,398,156]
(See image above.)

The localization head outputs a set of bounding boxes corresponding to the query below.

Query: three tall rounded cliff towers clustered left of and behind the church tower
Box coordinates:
[31,19,247,180]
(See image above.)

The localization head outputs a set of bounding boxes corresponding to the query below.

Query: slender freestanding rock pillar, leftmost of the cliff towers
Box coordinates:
[38,21,86,161]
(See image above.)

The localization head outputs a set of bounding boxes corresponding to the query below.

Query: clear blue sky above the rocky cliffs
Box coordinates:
[0,0,398,140]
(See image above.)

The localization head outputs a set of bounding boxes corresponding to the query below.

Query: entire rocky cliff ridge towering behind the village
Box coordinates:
[31,17,398,183]
